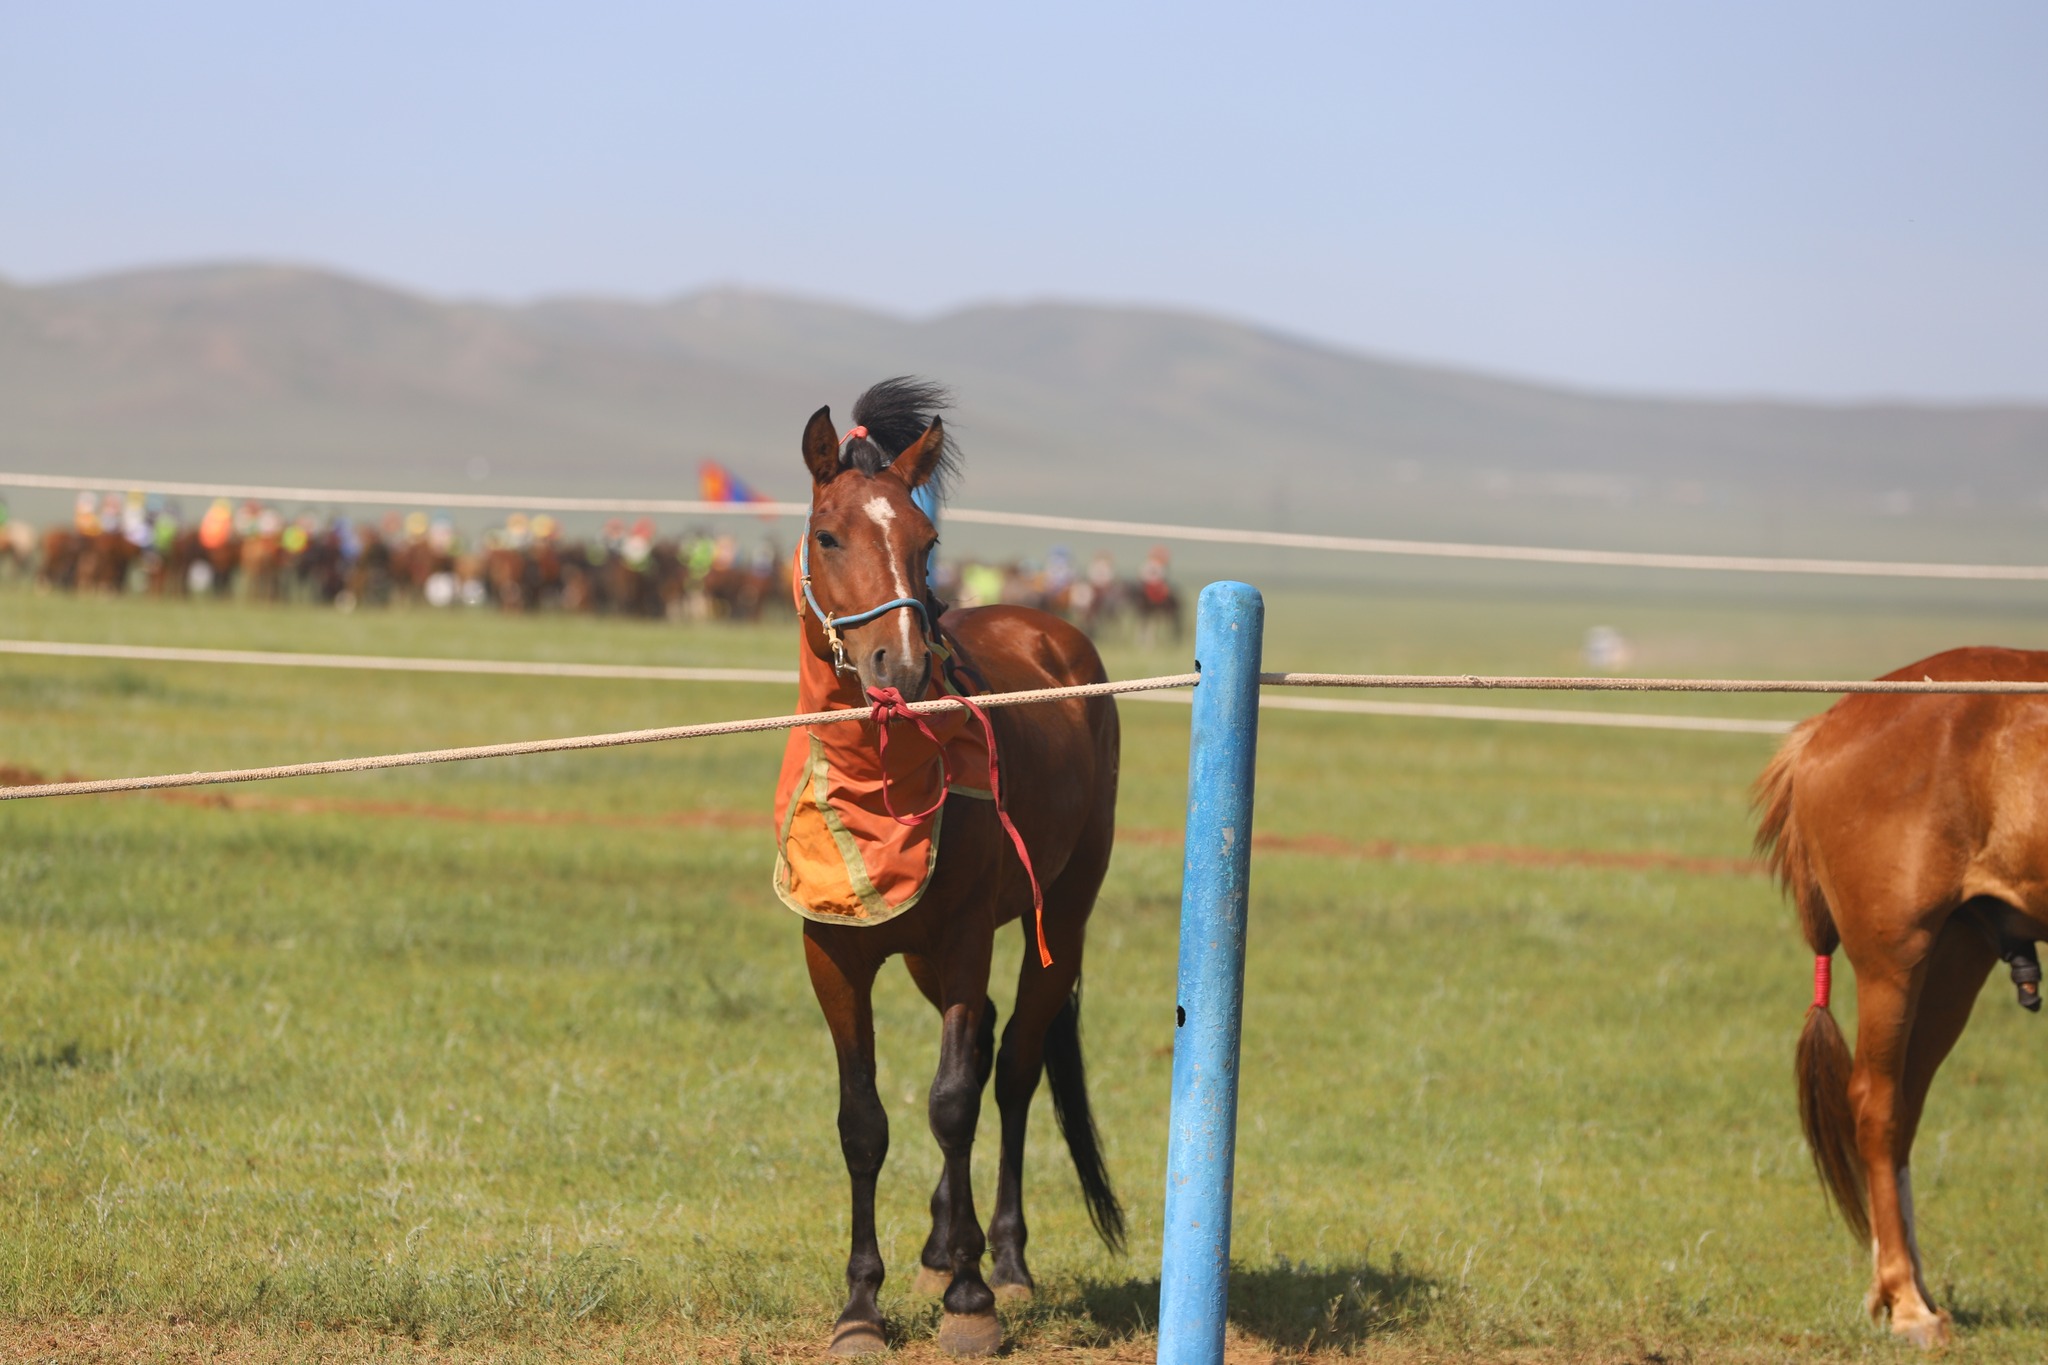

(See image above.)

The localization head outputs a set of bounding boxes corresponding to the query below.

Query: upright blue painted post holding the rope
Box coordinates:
[1159,583,1266,1365]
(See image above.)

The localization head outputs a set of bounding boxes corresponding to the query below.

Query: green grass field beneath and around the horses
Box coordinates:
[0,589,2048,1361]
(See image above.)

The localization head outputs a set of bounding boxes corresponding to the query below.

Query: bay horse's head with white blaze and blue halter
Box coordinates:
[803,391,946,700]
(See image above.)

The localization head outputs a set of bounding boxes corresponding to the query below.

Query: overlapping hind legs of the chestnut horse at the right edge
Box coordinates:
[1849,923,1989,1347]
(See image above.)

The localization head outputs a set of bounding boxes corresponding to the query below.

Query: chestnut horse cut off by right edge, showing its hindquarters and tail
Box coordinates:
[1757,649,2048,1347]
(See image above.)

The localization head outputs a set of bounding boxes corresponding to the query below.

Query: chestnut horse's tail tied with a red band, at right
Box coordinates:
[1755,716,1870,1242]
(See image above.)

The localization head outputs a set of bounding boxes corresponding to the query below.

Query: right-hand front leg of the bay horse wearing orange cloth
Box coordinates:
[930,923,1004,1355]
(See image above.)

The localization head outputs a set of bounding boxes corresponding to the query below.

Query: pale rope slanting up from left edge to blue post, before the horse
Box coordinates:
[0,673,1202,800]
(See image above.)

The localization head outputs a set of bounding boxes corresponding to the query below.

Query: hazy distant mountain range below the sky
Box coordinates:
[0,264,2048,557]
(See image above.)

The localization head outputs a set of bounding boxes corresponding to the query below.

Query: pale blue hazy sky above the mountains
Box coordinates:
[0,0,2048,399]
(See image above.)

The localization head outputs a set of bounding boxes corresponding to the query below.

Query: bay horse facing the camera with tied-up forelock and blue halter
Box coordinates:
[803,381,1122,1355]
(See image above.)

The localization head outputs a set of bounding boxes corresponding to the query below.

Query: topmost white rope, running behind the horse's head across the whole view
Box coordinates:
[0,473,2048,583]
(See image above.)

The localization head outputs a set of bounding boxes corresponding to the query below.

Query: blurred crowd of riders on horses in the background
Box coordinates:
[0,493,1182,639]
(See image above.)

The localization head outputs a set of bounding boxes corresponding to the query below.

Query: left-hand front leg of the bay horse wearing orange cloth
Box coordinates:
[803,925,889,1355]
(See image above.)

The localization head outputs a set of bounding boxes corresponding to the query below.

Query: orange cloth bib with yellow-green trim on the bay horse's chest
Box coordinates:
[774,651,991,925]
